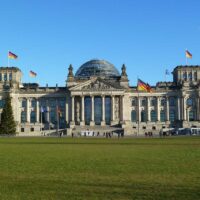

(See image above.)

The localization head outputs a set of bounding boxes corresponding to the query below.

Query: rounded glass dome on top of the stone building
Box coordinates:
[75,60,120,78]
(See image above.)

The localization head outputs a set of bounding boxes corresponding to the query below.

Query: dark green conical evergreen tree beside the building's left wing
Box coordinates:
[0,93,16,135]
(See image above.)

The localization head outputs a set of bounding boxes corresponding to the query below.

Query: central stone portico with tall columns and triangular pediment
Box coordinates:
[70,77,124,126]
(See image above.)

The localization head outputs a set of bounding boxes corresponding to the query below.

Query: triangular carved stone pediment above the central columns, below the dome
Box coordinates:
[70,78,122,91]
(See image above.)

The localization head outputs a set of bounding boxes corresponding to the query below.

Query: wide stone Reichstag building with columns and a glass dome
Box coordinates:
[0,60,200,135]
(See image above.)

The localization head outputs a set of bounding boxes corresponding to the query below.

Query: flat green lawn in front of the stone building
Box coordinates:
[0,137,200,200]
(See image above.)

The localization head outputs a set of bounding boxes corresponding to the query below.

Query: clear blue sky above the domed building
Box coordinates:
[0,0,200,86]
